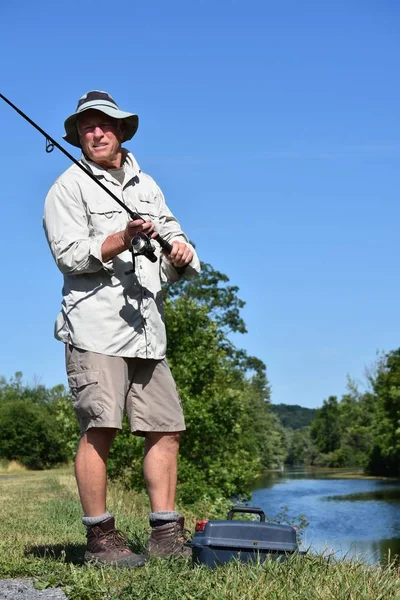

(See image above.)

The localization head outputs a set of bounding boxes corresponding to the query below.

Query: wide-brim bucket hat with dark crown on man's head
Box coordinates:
[63,90,139,148]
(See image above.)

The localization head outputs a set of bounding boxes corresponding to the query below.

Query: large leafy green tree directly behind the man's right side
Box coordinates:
[165,265,285,497]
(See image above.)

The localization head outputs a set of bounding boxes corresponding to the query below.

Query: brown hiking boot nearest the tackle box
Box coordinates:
[147,517,192,558]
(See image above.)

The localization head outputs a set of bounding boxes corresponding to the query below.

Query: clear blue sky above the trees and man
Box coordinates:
[0,0,400,407]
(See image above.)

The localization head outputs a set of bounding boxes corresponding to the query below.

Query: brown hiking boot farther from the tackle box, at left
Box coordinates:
[85,517,146,567]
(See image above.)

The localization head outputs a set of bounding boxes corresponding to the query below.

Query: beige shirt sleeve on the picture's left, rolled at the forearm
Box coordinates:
[43,181,114,275]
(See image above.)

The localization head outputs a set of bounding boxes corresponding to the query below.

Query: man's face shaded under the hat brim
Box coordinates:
[77,110,123,169]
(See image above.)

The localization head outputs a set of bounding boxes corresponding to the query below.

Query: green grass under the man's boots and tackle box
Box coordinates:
[0,468,400,600]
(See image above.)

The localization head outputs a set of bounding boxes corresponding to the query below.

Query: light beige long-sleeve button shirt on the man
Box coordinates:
[43,150,200,359]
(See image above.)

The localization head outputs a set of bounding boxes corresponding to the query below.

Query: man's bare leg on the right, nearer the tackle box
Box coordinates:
[143,432,181,512]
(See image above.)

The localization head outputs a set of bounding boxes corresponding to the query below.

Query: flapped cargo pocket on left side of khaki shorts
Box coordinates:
[68,371,104,421]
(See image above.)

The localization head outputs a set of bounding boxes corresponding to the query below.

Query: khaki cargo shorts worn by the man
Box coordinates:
[65,344,185,435]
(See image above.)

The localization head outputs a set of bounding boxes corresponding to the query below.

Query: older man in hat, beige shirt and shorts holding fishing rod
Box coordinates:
[44,91,200,566]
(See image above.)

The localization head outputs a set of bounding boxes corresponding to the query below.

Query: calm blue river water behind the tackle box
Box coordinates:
[250,469,400,563]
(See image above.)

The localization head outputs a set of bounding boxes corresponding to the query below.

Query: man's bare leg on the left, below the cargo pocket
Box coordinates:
[75,427,117,517]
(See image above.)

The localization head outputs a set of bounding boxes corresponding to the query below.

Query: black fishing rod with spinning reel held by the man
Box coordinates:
[0,94,172,262]
